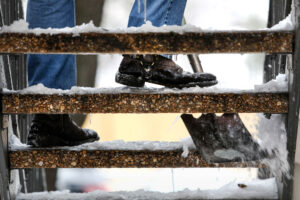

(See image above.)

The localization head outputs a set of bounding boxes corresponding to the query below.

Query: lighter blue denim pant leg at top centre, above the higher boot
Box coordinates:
[128,0,186,59]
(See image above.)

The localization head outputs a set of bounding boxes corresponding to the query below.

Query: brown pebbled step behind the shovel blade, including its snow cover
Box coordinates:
[9,141,265,169]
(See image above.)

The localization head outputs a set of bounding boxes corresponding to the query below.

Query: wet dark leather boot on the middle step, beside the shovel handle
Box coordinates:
[116,55,217,88]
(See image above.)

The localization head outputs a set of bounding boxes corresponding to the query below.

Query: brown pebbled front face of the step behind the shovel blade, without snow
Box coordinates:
[9,149,265,169]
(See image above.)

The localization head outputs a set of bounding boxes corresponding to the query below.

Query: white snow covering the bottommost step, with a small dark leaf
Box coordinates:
[17,178,278,200]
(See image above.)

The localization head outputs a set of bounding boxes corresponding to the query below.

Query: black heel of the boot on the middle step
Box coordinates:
[116,72,145,87]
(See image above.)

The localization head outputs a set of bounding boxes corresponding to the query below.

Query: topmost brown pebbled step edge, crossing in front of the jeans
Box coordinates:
[0,30,294,54]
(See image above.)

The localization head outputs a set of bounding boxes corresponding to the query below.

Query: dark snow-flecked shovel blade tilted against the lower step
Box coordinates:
[181,114,266,163]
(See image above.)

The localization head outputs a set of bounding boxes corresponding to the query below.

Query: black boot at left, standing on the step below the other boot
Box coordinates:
[27,114,99,147]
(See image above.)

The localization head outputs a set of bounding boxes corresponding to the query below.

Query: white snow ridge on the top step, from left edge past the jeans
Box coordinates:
[0,19,203,36]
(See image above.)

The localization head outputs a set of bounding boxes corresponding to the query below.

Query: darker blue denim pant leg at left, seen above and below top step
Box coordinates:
[27,0,76,89]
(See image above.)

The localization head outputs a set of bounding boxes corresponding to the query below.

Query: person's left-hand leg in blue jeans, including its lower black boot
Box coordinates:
[27,0,99,147]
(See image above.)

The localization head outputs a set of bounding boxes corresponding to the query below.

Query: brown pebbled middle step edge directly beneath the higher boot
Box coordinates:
[2,89,288,114]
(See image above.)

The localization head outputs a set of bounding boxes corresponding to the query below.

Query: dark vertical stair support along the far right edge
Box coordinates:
[281,0,300,200]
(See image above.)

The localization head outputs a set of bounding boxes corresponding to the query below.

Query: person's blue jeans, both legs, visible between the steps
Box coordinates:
[27,0,186,89]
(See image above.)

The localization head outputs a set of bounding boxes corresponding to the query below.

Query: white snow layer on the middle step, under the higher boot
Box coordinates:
[3,74,288,95]
